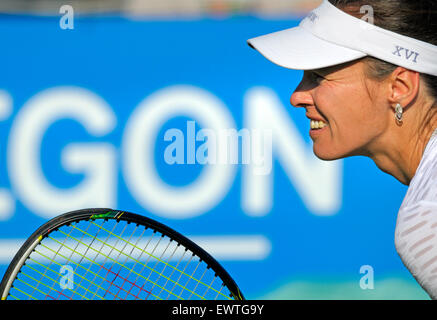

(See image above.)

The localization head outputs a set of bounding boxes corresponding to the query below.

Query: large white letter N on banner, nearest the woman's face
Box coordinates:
[242,87,342,216]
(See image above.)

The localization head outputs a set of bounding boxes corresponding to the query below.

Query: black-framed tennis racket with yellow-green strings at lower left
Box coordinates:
[0,208,244,300]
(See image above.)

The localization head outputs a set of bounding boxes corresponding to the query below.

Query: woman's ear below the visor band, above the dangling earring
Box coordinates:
[389,67,420,108]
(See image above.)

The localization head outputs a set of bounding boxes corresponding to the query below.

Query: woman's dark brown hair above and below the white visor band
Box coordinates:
[329,0,437,102]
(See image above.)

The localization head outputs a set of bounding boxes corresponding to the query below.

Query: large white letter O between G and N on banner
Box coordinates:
[122,85,235,219]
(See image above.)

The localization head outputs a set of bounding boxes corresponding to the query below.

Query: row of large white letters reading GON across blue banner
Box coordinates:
[0,85,342,220]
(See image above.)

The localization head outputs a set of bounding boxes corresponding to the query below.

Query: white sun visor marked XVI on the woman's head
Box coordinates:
[247,0,437,76]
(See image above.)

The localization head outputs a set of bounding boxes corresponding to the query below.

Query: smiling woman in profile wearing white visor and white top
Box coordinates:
[248,0,437,299]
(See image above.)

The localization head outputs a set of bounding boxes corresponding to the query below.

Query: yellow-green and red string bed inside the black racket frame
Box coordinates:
[6,219,231,300]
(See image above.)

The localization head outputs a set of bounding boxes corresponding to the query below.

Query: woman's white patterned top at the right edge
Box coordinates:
[395,130,437,299]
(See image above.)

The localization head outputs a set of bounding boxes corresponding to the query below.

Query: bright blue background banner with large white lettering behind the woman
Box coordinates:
[0,15,427,299]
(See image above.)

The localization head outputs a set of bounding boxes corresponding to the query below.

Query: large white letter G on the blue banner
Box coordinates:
[8,87,117,218]
